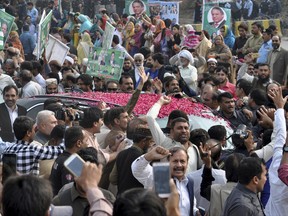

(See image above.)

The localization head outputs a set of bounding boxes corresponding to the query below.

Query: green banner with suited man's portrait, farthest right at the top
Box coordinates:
[202,5,231,39]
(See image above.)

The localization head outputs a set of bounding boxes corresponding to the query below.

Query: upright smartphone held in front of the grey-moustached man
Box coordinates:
[153,162,171,198]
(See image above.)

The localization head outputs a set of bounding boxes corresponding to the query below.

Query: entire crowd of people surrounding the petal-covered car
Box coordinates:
[0,0,288,216]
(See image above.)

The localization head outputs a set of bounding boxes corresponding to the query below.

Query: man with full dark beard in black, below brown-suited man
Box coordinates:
[252,63,274,91]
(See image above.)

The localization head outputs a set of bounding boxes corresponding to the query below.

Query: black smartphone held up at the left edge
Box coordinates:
[2,154,17,184]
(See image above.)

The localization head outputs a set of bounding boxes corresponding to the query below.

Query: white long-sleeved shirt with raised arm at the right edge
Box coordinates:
[265,109,288,216]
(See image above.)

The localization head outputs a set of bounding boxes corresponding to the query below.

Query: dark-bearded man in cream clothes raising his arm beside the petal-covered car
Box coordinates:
[146,96,202,171]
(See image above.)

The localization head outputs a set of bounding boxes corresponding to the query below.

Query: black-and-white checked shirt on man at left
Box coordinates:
[4,140,64,175]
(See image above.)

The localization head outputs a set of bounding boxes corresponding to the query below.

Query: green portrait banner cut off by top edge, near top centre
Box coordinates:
[125,0,149,16]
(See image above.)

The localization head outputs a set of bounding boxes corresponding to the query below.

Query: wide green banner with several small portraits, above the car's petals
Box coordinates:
[86,47,125,81]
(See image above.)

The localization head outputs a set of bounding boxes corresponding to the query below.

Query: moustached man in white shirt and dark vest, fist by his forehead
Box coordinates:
[131,146,200,216]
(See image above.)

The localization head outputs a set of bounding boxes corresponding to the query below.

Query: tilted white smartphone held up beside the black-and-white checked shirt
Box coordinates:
[64,153,85,177]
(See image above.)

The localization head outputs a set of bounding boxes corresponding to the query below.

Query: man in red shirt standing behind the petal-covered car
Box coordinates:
[216,66,236,98]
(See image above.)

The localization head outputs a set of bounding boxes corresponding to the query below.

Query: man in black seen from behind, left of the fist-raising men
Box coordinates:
[109,125,155,194]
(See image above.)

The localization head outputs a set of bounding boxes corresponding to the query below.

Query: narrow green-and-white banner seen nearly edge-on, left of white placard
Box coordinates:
[36,10,52,59]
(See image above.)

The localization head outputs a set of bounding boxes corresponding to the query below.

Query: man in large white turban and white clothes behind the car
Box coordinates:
[179,50,198,91]
